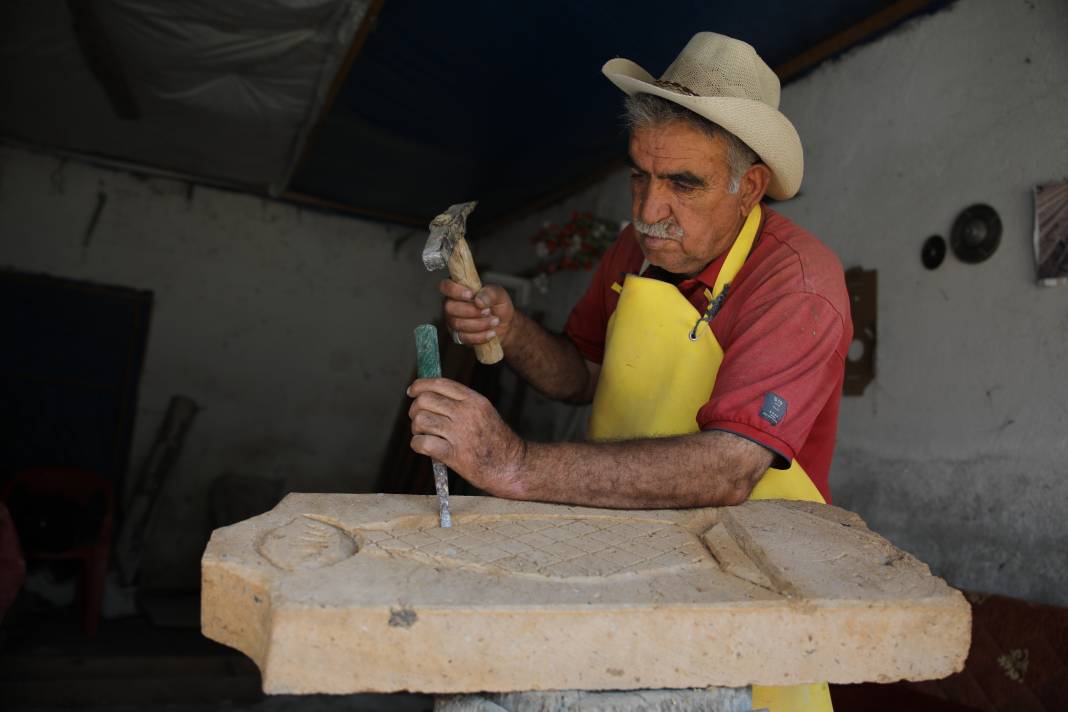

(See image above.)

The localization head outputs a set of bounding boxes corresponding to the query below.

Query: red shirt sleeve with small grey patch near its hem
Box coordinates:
[697,292,844,468]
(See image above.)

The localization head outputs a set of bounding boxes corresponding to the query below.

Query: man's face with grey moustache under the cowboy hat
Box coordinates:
[630,121,759,274]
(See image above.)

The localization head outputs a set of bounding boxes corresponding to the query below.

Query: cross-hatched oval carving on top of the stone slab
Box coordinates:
[360,517,711,579]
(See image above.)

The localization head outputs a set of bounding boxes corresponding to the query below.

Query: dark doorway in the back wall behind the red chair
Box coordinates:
[0,271,152,493]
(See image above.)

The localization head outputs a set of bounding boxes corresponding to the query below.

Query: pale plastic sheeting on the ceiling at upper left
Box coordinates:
[0,0,371,194]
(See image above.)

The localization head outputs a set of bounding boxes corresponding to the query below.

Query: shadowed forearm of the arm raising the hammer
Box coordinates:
[502,311,593,402]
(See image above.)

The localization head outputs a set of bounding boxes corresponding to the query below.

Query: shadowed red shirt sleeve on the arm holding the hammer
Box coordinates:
[564,226,634,363]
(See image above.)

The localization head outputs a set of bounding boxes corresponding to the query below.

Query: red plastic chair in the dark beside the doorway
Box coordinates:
[0,468,115,636]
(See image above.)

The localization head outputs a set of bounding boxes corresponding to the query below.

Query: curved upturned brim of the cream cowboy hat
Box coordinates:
[601,58,804,201]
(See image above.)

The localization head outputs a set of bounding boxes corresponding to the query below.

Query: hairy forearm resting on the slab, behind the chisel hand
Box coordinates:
[497,431,772,508]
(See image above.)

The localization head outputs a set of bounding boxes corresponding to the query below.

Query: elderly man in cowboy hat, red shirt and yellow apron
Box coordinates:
[409,32,852,711]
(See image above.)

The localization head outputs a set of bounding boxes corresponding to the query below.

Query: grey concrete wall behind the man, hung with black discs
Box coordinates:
[487,0,1068,603]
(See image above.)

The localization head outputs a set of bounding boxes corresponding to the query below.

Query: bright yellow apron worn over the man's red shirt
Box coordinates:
[590,205,832,712]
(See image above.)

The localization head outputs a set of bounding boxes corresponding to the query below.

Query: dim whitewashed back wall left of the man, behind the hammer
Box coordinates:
[0,147,439,584]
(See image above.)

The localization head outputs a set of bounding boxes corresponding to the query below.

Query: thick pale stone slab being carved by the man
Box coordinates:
[202,494,971,693]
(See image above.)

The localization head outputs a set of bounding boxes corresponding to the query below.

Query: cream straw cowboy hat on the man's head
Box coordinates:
[601,32,804,201]
